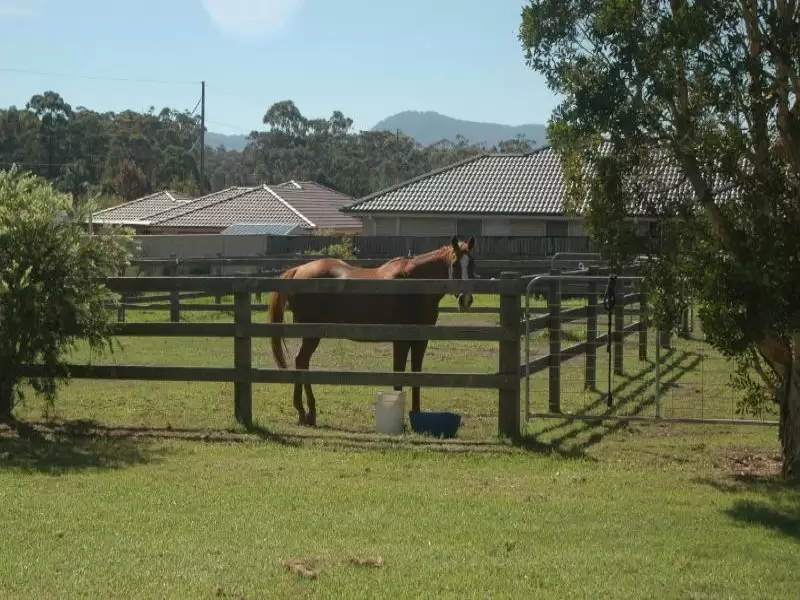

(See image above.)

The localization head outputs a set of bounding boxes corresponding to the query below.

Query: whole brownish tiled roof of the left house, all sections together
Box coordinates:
[93,181,361,235]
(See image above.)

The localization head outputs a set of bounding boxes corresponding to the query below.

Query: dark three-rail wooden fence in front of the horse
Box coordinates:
[28,273,525,437]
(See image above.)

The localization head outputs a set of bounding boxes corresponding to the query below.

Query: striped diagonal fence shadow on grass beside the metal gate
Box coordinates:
[526,349,703,453]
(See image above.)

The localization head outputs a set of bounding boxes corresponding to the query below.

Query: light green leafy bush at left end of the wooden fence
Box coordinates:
[0,167,132,421]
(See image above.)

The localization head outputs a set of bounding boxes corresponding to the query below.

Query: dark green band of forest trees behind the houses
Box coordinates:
[0,91,531,204]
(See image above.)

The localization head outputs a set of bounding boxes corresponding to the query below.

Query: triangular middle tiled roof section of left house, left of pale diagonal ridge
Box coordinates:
[152,186,314,228]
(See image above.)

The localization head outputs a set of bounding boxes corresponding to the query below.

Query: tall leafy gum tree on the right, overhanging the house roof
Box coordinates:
[519,0,800,479]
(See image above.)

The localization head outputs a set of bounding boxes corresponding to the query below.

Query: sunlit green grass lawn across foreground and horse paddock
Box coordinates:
[0,292,800,598]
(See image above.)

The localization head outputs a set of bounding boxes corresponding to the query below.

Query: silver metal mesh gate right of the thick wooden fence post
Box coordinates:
[522,270,777,425]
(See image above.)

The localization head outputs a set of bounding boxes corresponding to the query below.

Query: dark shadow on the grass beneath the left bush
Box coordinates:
[0,421,163,475]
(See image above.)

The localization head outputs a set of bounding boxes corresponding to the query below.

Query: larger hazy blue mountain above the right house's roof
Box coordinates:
[372,110,547,148]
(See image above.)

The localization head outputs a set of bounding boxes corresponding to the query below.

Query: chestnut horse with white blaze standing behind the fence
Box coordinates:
[268,236,475,426]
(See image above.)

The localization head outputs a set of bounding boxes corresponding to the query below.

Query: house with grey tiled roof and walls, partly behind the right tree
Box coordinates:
[342,147,655,237]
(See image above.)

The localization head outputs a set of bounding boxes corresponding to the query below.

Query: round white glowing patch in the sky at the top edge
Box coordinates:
[202,0,302,37]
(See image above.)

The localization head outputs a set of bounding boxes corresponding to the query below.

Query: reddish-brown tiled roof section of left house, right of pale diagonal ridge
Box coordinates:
[272,180,361,229]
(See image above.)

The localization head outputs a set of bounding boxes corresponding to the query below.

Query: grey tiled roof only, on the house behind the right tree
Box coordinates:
[342,147,736,215]
